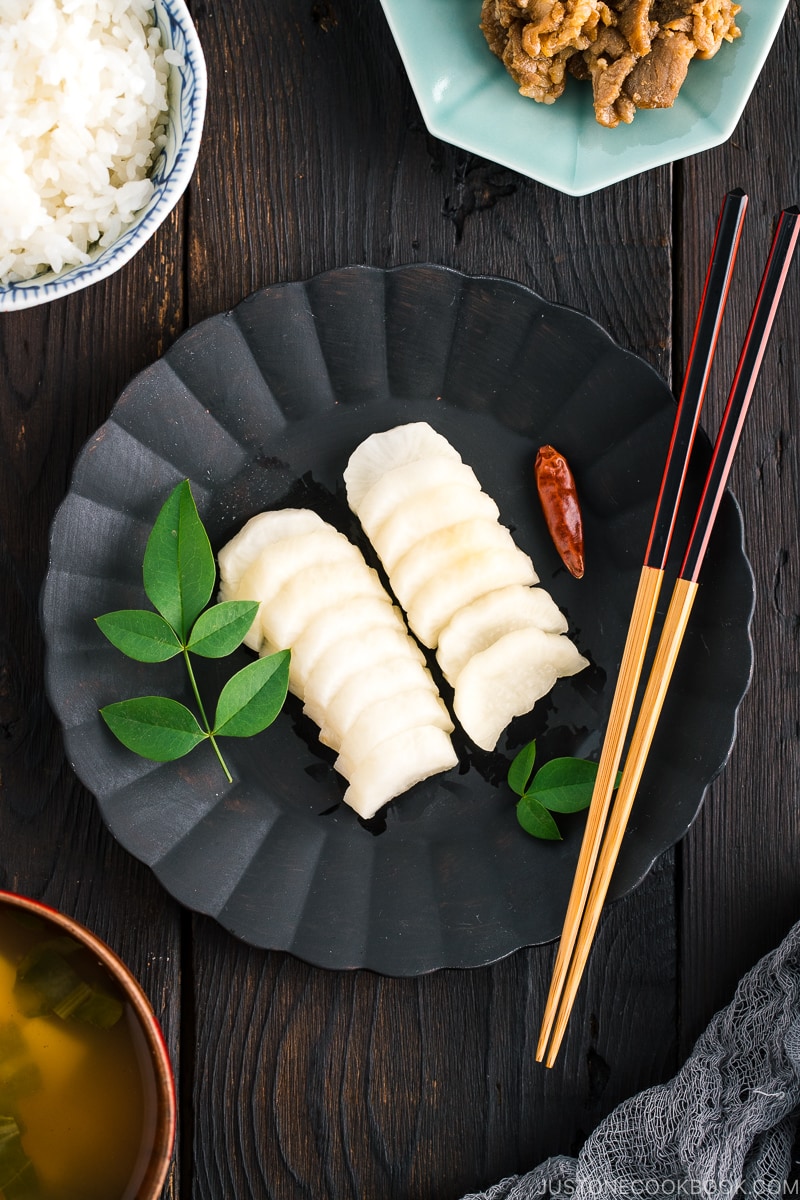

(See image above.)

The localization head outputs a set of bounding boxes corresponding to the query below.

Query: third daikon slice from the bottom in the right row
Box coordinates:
[404,546,537,647]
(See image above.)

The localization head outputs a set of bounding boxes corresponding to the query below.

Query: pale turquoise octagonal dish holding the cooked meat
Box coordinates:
[380,0,789,196]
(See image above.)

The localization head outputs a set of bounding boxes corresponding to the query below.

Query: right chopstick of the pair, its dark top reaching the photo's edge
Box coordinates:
[537,208,800,1067]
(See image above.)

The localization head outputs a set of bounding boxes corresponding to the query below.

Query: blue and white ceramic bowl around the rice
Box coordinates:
[0,0,207,312]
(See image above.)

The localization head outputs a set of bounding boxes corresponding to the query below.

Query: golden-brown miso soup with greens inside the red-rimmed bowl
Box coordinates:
[0,904,156,1200]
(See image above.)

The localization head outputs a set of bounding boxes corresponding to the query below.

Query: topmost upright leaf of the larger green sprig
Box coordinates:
[143,480,216,642]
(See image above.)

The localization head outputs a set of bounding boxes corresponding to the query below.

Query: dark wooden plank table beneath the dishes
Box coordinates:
[0,0,800,1200]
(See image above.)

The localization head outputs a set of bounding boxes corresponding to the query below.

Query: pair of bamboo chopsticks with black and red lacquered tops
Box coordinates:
[536,190,800,1067]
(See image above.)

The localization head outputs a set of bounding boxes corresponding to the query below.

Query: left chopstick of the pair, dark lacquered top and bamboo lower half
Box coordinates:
[536,190,747,1062]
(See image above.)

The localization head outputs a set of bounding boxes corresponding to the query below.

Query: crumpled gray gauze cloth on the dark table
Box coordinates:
[464,923,800,1200]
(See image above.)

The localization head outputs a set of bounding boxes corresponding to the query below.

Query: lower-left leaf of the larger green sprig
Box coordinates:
[100,696,207,762]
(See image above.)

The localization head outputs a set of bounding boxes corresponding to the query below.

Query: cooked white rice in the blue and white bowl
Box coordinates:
[0,0,176,284]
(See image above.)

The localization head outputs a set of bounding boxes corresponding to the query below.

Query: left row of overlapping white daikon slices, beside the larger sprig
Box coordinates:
[219,501,462,815]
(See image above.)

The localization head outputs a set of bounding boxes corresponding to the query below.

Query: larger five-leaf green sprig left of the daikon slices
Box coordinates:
[96,480,289,782]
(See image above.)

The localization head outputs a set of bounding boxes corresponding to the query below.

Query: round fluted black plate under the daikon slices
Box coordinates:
[42,266,753,976]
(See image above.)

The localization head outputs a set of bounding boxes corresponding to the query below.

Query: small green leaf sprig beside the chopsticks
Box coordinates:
[507,740,621,841]
